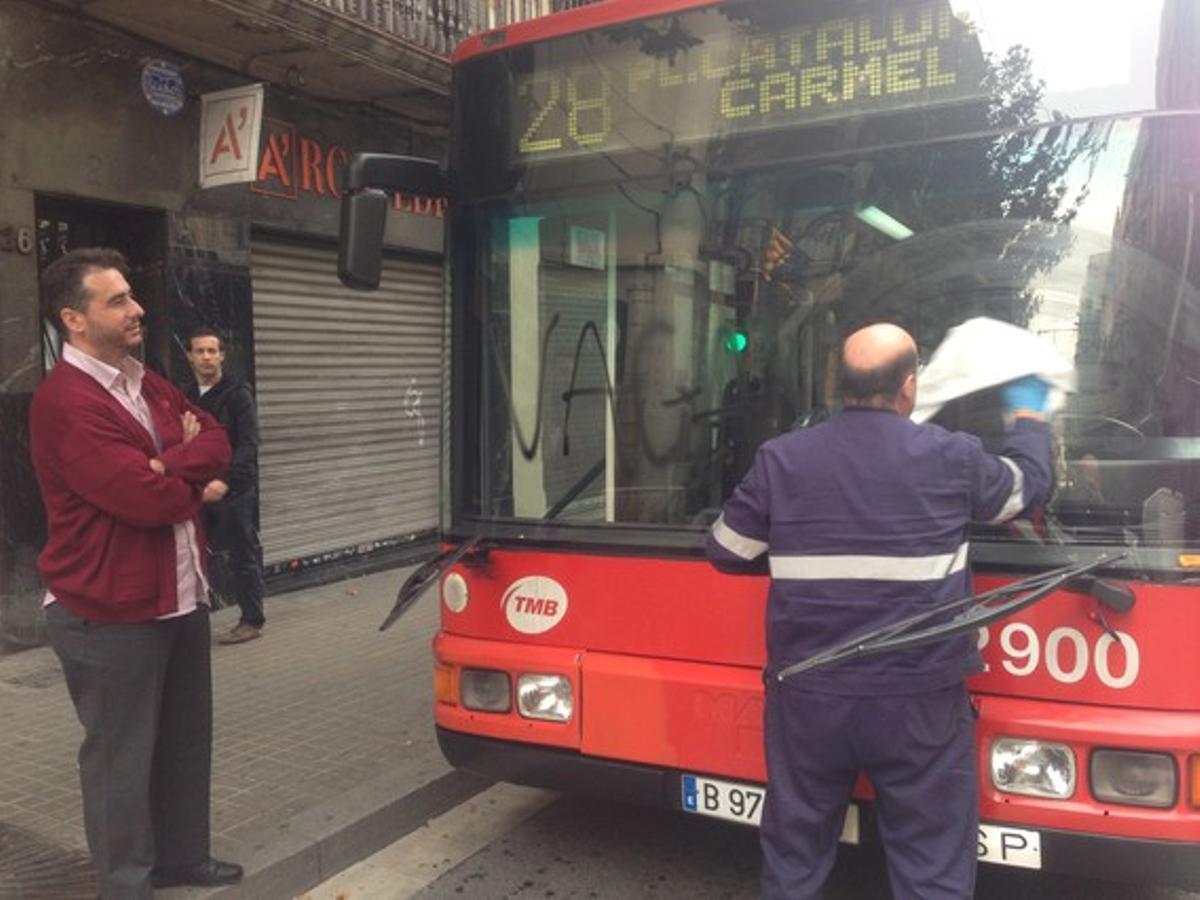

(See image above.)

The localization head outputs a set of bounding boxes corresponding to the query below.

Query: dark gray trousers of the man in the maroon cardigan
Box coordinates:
[46,602,212,900]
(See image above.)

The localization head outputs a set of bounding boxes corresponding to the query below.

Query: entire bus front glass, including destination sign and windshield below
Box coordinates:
[452,1,1200,572]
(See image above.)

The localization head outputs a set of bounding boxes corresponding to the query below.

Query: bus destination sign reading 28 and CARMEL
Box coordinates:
[512,0,986,158]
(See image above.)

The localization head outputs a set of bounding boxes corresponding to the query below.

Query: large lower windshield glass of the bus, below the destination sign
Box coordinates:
[465,112,1200,573]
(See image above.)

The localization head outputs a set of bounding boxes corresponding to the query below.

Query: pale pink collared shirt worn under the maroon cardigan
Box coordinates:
[43,343,209,619]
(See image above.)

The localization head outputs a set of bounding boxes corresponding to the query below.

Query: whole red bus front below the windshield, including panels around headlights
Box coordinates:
[434,550,1200,841]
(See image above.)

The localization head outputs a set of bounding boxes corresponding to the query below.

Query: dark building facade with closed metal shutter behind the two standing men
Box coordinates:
[0,0,463,647]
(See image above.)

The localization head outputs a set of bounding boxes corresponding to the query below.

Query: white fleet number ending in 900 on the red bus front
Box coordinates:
[979,622,1141,690]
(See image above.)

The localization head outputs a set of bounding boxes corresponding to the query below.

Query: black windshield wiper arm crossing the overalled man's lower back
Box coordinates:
[776,553,1124,682]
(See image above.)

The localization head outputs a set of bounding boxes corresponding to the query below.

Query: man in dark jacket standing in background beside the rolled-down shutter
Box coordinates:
[185,328,266,643]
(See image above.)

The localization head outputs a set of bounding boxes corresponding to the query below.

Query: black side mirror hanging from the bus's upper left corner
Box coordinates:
[337,154,446,290]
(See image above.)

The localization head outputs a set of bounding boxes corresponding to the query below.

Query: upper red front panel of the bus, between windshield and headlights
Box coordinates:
[443,550,1200,710]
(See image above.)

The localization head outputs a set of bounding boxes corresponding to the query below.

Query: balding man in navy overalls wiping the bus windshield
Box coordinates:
[708,324,1052,900]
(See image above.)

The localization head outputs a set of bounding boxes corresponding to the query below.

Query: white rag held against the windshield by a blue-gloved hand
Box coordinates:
[912,316,1075,422]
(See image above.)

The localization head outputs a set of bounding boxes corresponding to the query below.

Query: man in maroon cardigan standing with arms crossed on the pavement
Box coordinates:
[30,250,241,899]
